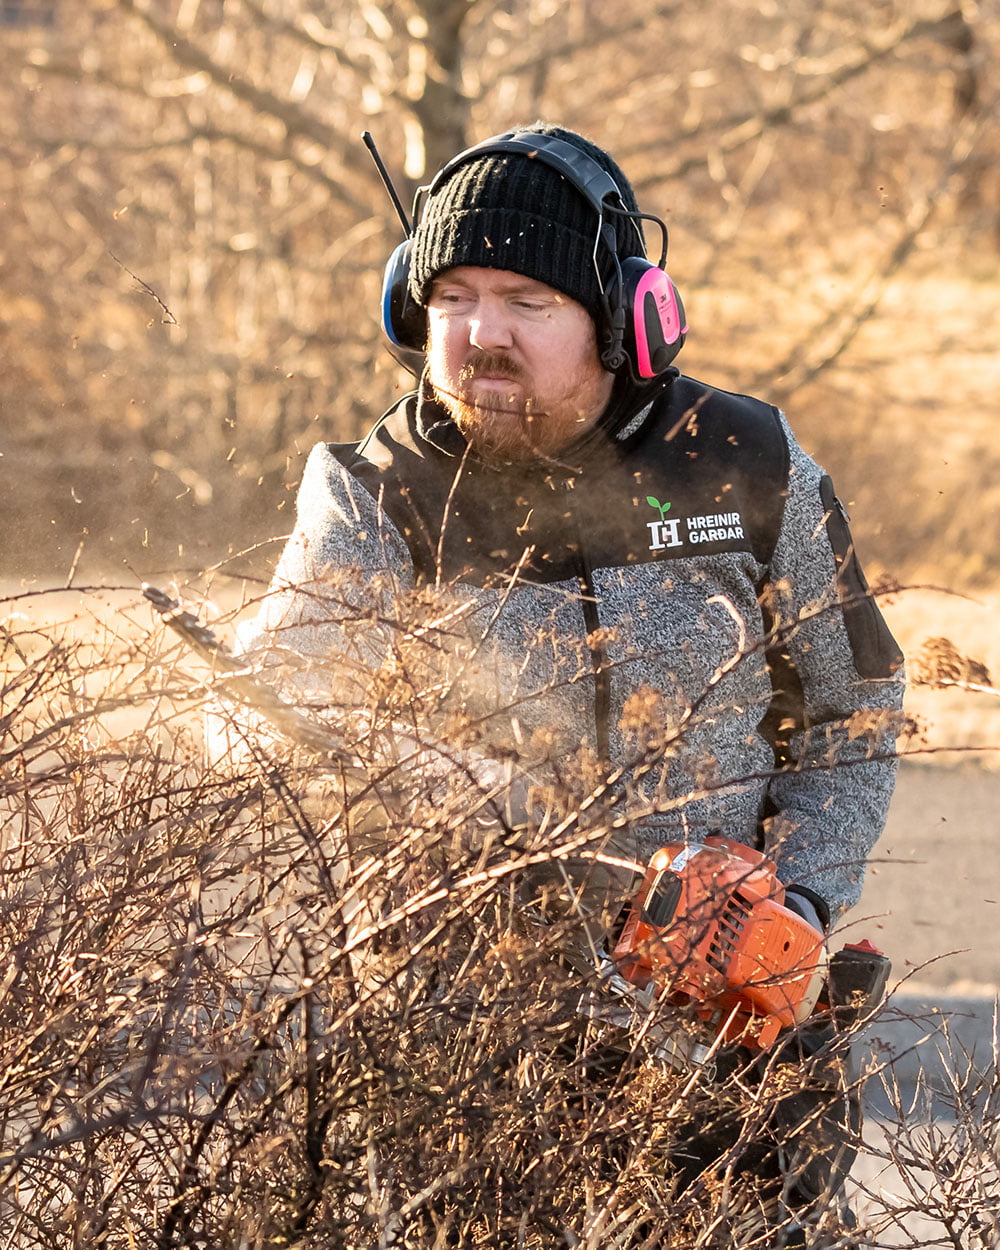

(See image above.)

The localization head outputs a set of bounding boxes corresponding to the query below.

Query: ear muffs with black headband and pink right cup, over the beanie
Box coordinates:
[381,131,688,381]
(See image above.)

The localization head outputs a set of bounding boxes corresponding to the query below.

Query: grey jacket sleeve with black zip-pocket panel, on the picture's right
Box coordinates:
[765,415,903,919]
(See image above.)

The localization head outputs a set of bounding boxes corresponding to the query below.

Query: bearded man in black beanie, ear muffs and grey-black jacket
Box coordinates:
[242,126,901,1240]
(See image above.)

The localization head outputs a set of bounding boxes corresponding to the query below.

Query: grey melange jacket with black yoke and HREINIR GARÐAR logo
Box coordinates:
[244,375,903,919]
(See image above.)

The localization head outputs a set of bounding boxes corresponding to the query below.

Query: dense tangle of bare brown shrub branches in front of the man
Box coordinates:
[0,590,995,1250]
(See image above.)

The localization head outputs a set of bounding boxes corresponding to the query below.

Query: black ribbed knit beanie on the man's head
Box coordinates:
[409,123,643,324]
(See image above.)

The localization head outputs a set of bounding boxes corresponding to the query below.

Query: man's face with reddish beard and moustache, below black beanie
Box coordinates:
[428,265,614,463]
